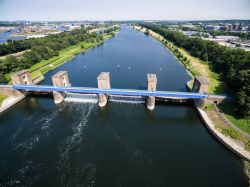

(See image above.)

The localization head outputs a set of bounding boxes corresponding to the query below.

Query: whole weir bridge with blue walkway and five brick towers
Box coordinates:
[0,71,225,110]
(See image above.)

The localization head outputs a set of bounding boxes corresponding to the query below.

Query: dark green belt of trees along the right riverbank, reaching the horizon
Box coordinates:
[141,23,250,116]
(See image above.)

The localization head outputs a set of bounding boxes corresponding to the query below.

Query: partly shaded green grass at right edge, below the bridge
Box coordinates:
[219,103,250,134]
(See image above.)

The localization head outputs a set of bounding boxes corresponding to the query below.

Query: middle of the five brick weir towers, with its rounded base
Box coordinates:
[97,72,111,107]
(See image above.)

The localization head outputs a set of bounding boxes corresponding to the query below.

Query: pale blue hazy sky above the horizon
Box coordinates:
[0,0,250,21]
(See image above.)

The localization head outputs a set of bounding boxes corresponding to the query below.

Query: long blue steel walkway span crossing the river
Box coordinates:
[12,85,208,99]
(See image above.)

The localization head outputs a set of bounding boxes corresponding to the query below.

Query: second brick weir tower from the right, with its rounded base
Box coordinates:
[147,74,157,110]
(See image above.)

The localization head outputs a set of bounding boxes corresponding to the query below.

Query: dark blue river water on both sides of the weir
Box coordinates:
[0,26,247,187]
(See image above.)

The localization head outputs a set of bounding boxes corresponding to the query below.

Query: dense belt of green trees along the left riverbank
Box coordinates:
[0,28,113,83]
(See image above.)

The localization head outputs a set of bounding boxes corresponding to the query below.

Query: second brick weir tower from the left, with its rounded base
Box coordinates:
[52,71,71,104]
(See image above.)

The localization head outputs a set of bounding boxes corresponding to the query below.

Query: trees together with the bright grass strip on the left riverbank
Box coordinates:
[0,27,118,82]
